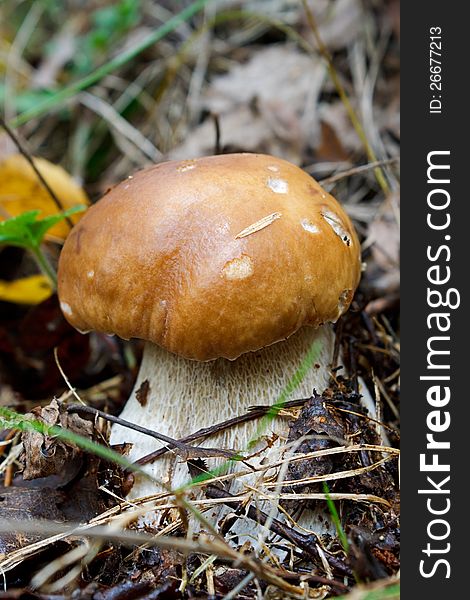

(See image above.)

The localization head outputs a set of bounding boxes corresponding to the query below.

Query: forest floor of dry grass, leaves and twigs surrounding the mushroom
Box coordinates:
[0,0,400,600]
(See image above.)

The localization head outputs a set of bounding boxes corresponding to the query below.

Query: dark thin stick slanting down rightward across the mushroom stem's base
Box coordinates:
[189,463,352,575]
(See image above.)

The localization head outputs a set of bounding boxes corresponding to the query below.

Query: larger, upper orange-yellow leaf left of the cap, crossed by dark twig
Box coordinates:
[0,154,89,239]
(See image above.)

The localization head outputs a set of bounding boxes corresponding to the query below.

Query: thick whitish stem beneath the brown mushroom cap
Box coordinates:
[110,325,334,528]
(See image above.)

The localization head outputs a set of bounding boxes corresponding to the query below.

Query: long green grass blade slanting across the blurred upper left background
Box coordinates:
[9,0,212,127]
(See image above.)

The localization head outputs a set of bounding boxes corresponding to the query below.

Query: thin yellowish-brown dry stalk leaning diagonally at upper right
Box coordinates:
[302,0,390,196]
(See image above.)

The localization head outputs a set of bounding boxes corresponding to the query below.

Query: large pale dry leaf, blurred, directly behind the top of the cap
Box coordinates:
[170,44,325,162]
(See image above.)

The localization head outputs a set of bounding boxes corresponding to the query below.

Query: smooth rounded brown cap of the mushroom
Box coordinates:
[59,154,360,360]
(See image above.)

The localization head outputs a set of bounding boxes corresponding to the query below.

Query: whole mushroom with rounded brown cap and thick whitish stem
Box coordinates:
[58,153,361,536]
